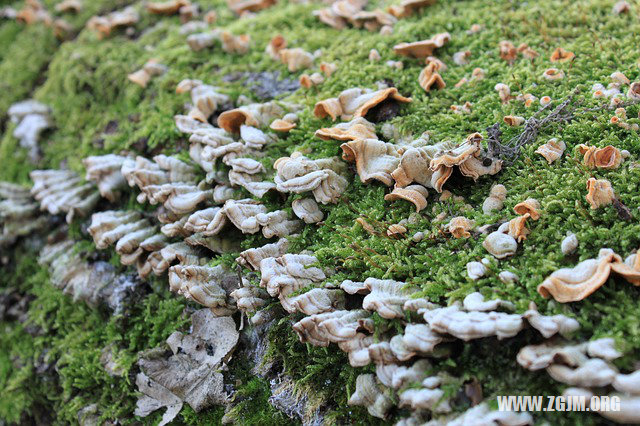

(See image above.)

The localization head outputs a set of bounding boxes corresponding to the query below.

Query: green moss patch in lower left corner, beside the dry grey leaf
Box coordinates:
[0,241,189,423]
